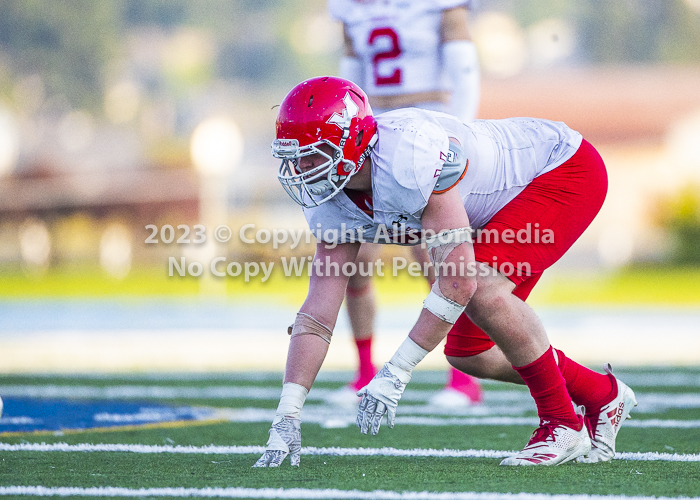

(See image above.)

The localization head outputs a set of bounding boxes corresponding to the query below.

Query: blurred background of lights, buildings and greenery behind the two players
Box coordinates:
[0,0,700,373]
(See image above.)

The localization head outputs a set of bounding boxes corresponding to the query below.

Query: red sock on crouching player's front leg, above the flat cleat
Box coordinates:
[513,347,581,430]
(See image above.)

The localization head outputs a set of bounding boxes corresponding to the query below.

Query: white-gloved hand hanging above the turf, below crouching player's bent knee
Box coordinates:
[356,363,411,436]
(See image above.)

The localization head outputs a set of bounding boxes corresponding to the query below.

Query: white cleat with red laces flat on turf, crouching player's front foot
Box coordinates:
[501,415,591,465]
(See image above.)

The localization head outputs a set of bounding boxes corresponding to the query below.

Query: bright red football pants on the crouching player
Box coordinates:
[445,140,608,356]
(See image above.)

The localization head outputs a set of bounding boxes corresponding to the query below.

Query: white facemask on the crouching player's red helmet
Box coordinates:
[272,139,361,208]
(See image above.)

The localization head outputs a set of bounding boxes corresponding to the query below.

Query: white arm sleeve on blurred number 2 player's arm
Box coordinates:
[442,40,481,122]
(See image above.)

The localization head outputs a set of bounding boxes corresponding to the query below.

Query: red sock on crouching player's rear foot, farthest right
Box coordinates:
[555,349,615,413]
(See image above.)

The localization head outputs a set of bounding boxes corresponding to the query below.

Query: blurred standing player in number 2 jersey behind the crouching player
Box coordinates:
[328,0,482,406]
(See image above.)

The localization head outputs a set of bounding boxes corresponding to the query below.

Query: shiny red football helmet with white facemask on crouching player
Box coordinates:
[272,76,377,208]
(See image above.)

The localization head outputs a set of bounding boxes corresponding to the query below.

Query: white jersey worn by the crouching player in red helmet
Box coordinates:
[304,108,582,244]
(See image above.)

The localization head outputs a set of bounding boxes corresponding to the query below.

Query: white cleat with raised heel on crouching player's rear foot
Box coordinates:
[579,365,637,463]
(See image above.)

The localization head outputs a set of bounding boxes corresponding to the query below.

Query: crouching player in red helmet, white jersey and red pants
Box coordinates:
[255,77,636,467]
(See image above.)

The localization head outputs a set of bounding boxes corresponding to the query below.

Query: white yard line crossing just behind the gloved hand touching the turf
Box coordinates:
[0,443,700,462]
